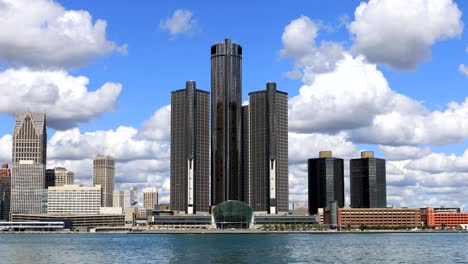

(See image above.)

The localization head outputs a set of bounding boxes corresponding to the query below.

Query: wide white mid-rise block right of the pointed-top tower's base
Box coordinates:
[47,185,101,214]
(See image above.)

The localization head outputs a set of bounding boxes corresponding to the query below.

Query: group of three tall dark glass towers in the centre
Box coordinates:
[170,39,289,214]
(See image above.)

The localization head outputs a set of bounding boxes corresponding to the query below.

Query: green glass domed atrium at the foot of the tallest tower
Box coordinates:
[213,200,253,228]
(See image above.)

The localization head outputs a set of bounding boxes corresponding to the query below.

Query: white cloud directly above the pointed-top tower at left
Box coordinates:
[0,68,122,129]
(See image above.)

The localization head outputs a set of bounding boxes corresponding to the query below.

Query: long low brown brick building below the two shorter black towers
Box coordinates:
[336,208,421,227]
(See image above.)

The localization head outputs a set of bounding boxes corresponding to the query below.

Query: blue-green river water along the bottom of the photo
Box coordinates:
[0,233,468,264]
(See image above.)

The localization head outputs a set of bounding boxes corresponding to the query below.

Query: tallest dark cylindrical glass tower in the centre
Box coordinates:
[211,39,243,205]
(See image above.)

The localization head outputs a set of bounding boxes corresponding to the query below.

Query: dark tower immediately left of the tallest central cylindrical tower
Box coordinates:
[170,81,210,214]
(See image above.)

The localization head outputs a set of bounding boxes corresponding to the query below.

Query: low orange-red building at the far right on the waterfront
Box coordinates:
[421,207,468,227]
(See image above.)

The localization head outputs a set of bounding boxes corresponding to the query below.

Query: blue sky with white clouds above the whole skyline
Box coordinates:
[0,0,468,208]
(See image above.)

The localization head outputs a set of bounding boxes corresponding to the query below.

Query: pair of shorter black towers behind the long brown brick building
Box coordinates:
[308,151,387,215]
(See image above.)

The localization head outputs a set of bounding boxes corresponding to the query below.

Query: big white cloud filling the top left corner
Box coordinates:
[0,0,126,68]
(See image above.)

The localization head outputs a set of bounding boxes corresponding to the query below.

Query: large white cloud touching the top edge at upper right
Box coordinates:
[349,0,463,70]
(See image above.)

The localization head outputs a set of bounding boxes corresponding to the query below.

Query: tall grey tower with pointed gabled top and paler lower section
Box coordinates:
[11,112,47,214]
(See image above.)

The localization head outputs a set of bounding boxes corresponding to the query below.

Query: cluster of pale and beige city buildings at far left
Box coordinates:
[0,112,157,219]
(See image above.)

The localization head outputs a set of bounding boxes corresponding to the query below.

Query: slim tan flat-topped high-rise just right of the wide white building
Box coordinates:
[93,155,115,207]
